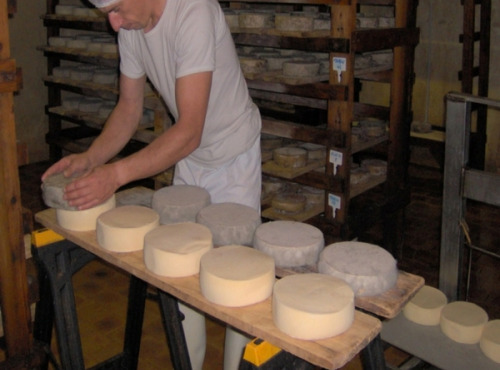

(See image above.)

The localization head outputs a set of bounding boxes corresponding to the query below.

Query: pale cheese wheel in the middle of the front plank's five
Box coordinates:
[144,222,213,277]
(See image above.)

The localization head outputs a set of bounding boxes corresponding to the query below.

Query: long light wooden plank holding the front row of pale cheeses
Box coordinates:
[35,209,381,369]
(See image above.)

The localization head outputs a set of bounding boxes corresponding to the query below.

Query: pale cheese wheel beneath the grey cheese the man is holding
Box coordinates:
[56,195,116,231]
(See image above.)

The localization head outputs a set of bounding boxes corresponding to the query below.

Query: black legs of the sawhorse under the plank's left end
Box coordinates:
[33,240,147,370]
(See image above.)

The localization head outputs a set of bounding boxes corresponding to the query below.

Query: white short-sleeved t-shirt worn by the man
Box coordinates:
[118,0,261,167]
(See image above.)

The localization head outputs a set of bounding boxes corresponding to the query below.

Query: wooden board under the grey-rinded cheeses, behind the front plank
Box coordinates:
[276,266,425,319]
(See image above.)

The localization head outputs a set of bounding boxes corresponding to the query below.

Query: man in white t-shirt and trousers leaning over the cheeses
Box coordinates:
[42,0,261,369]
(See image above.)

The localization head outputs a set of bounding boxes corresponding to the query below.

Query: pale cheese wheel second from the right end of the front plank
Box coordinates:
[200,245,275,307]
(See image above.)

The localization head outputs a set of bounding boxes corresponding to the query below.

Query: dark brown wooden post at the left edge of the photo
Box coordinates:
[0,0,32,357]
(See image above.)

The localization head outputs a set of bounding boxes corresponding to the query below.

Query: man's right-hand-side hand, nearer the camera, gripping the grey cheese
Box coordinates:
[64,164,120,210]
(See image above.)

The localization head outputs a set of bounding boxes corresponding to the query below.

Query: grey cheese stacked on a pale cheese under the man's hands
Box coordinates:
[42,173,116,231]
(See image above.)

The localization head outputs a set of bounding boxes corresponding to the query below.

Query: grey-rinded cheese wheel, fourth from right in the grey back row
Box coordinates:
[152,185,210,225]
